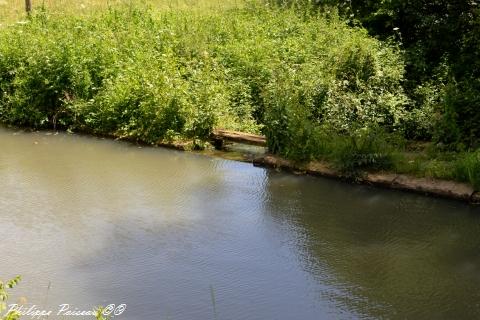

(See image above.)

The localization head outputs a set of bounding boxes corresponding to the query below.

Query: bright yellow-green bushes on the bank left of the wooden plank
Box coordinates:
[0,7,260,143]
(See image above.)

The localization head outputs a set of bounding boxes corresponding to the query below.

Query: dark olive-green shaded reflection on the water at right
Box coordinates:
[267,177,480,319]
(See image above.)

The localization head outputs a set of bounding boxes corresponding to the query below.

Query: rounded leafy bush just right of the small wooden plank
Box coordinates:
[263,22,414,160]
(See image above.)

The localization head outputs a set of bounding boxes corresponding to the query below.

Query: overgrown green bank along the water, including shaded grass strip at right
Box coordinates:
[0,0,480,189]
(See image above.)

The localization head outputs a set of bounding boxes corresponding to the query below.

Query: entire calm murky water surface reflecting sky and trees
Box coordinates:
[0,129,480,320]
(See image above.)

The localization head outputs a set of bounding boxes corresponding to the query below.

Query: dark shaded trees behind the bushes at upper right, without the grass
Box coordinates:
[271,0,480,146]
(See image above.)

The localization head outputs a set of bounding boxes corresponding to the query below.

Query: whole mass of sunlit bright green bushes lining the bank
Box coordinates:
[0,6,406,143]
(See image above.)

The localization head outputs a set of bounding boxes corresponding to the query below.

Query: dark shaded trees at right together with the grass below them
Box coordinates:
[267,0,480,189]
